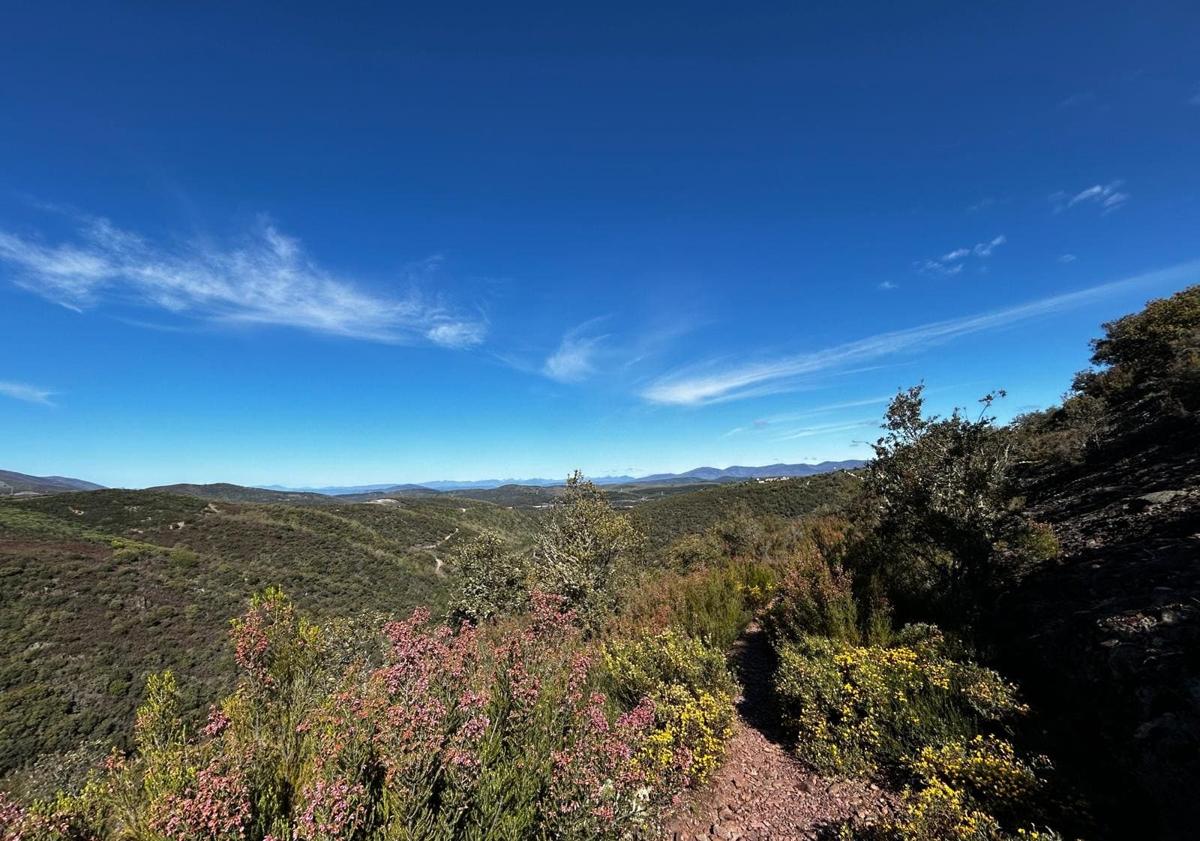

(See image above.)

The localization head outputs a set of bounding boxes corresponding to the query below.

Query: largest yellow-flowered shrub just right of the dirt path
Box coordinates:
[775,626,1025,775]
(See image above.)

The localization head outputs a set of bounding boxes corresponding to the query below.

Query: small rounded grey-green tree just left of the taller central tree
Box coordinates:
[450,531,529,624]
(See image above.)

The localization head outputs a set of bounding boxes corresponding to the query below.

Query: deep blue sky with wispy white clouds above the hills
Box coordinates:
[0,2,1200,486]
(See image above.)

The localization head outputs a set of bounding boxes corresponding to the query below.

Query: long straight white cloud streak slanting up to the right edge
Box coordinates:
[641,260,1200,406]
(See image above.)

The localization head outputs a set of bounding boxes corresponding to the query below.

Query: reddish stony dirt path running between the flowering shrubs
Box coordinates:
[666,625,893,841]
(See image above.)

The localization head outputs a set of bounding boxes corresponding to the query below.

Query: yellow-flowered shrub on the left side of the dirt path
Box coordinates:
[604,630,736,786]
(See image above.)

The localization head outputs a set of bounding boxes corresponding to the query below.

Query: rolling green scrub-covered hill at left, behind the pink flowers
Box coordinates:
[0,491,534,775]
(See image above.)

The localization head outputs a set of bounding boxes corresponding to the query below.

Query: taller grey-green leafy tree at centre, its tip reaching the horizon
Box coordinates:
[534,470,642,627]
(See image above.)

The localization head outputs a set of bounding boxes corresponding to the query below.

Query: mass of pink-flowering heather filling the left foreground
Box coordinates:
[0,590,696,841]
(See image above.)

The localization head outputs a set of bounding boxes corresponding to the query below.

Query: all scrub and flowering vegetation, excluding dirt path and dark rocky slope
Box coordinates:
[0,289,1200,841]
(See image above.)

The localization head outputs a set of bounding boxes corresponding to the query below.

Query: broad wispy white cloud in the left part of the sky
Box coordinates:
[0,220,486,348]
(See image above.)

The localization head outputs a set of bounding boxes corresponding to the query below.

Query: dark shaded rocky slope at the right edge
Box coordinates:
[990,435,1200,839]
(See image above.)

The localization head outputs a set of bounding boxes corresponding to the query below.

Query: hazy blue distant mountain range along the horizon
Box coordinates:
[263,458,866,497]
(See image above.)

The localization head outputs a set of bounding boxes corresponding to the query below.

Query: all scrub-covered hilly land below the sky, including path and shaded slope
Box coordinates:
[0,287,1200,841]
